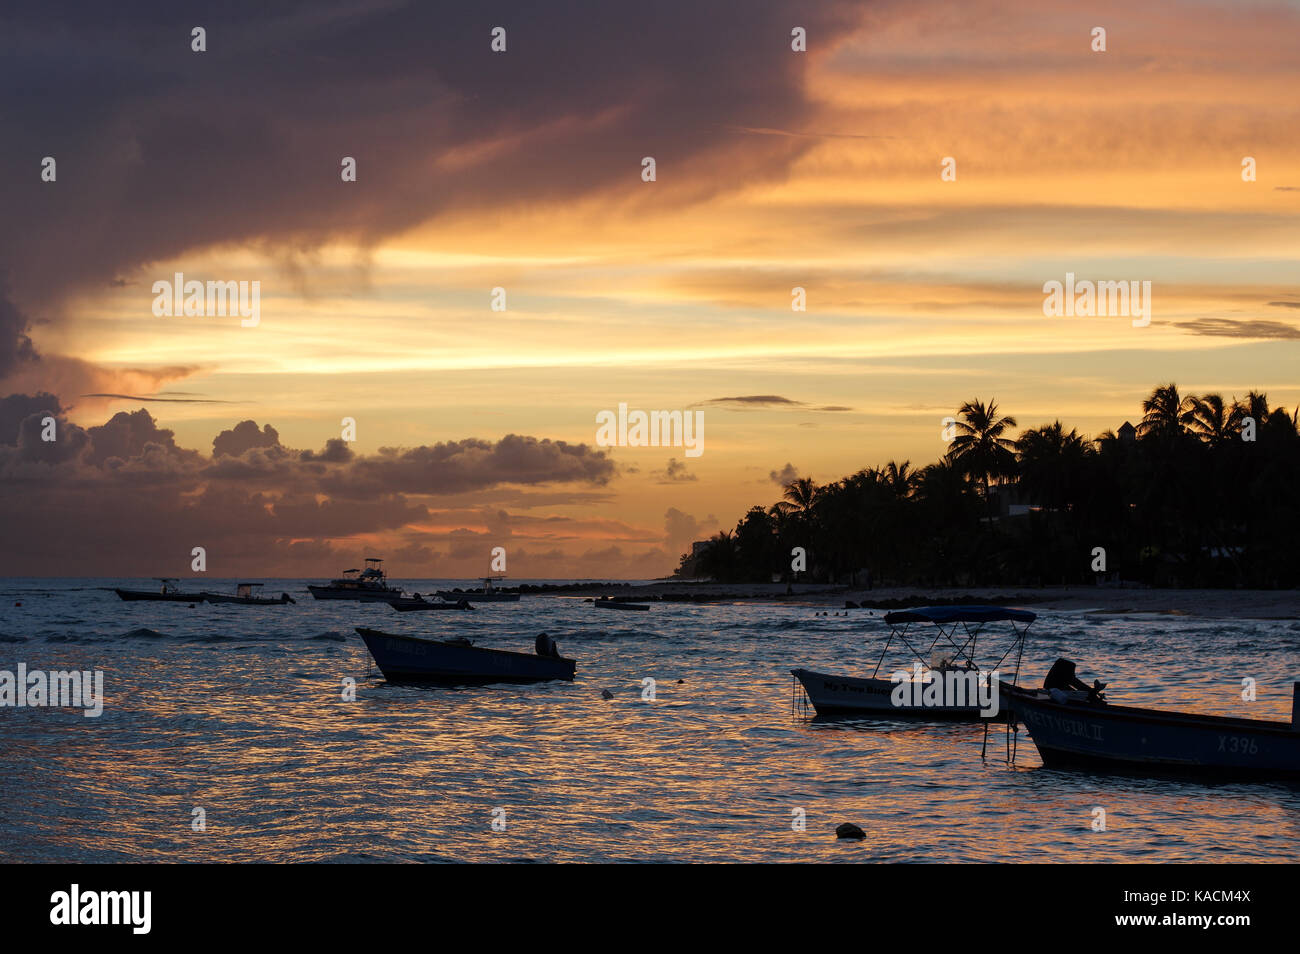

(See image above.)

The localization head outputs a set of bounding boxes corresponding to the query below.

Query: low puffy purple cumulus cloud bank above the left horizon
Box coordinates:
[0,394,616,576]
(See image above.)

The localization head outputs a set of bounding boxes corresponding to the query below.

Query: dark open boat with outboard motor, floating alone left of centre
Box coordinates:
[356,626,577,685]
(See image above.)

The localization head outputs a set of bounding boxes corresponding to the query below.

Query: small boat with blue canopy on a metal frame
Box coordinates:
[790,606,1037,721]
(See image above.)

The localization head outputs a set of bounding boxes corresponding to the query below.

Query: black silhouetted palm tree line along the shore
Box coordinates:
[676,383,1300,589]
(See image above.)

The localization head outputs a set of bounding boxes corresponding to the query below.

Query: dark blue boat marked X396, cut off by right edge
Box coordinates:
[1013,682,1300,780]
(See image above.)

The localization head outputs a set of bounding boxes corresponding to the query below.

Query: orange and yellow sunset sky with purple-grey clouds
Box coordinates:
[0,0,1300,578]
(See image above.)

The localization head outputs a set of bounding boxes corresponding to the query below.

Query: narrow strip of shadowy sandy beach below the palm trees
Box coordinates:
[551,582,1300,620]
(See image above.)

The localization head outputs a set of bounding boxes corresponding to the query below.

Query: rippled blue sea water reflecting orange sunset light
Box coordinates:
[0,580,1300,862]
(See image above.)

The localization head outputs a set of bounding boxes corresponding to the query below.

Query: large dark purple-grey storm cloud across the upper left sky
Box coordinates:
[0,0,859,374]
